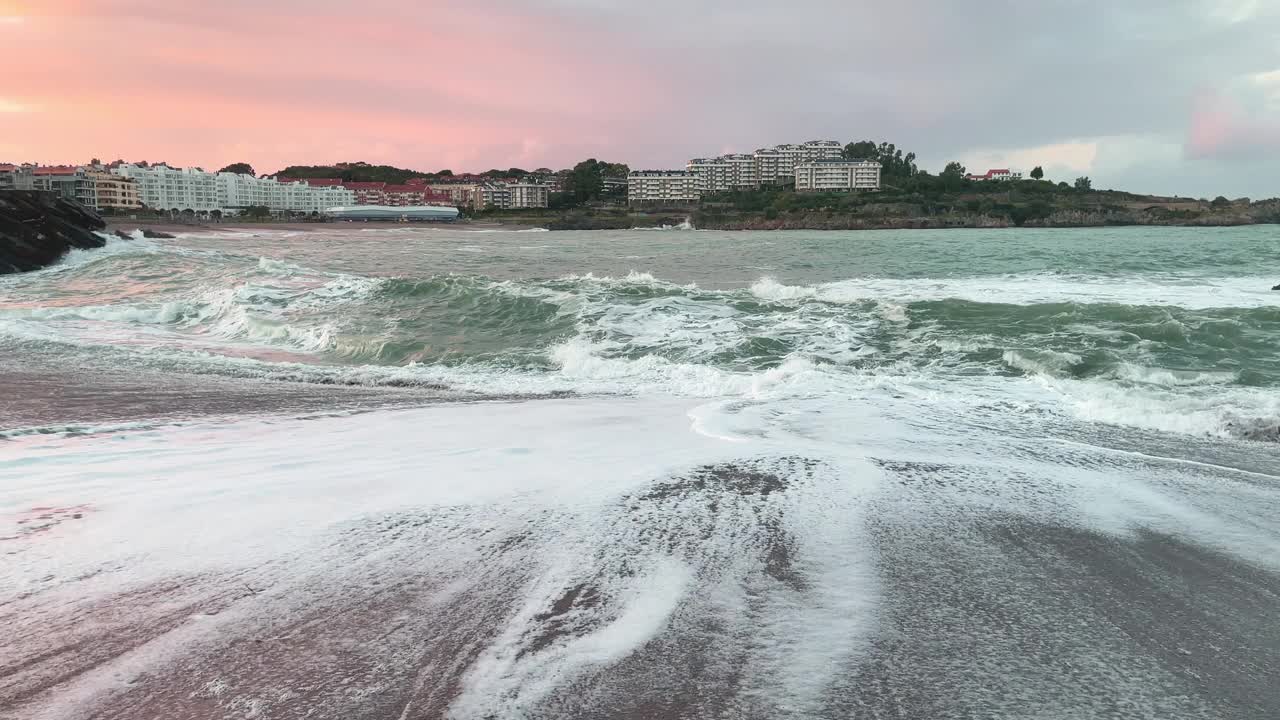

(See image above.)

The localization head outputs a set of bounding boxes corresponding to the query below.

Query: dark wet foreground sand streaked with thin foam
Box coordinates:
[0,459,1280,720]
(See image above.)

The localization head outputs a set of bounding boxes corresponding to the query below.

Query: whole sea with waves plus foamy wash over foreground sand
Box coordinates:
[0,224,1280,720]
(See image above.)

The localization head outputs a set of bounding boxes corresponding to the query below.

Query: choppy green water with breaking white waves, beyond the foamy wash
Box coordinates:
[0,225,1280,436]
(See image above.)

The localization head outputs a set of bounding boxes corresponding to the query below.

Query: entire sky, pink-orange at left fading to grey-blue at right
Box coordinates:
[0,0,1280,199]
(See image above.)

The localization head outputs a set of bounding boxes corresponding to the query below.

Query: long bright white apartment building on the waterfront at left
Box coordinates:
[111,164,356,213]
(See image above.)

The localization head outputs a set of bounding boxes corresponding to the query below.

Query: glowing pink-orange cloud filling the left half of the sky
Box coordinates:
[0,0,678,170]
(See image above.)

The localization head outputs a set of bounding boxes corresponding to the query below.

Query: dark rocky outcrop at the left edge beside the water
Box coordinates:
[0,190,106,274]
